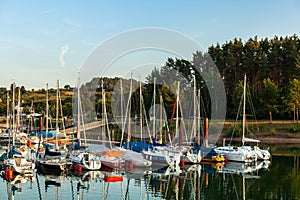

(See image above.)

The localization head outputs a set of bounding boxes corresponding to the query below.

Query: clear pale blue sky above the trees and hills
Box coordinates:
[0,0,300,89]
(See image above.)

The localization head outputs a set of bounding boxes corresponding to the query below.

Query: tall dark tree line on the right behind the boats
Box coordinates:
[148,35,300,121]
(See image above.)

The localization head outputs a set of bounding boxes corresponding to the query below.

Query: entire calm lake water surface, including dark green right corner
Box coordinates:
[0,144,300,200]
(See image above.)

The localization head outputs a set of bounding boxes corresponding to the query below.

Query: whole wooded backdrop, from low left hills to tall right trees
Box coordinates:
[0,35,300,121]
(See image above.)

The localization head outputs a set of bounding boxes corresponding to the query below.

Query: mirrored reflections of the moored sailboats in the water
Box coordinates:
[0,157,286,200]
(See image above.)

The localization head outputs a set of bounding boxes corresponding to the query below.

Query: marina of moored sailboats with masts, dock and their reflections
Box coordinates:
[1,76,299,200]
